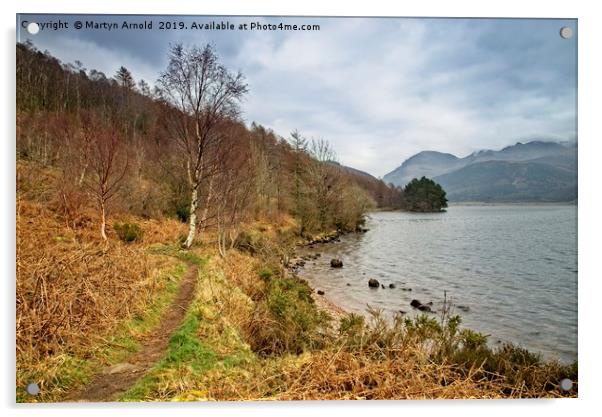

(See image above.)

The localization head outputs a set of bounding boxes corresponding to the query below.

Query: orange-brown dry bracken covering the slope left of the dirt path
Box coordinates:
[16,200,184,398]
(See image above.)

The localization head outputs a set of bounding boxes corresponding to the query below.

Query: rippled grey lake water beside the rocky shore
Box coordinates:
[300,205,577,362]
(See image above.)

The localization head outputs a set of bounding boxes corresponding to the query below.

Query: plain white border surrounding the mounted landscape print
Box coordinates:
[0,0,602,417]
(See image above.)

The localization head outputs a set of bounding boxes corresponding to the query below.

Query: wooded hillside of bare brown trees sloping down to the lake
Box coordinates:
[17,43,410,250]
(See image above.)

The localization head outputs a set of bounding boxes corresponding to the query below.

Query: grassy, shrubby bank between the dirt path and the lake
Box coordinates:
[121,244,577,401]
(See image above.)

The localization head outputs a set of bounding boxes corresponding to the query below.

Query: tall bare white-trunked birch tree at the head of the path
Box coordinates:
[158,44,248,248]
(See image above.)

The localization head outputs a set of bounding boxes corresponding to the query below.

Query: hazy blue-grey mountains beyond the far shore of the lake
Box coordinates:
[383,140,577,202]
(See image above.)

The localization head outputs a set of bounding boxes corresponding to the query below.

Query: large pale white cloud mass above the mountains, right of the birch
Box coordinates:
[233,20,574,176]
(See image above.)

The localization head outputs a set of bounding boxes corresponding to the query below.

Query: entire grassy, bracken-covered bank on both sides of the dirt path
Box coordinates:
[17,201,577,401]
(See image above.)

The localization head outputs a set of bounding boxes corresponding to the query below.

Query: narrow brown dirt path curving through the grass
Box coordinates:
[65,266,198,402]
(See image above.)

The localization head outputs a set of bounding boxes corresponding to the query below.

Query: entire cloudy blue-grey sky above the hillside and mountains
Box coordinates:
[17,15,577,176]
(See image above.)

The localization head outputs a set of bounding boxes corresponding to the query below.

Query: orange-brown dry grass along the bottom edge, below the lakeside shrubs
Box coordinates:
[272,330,575,400]
